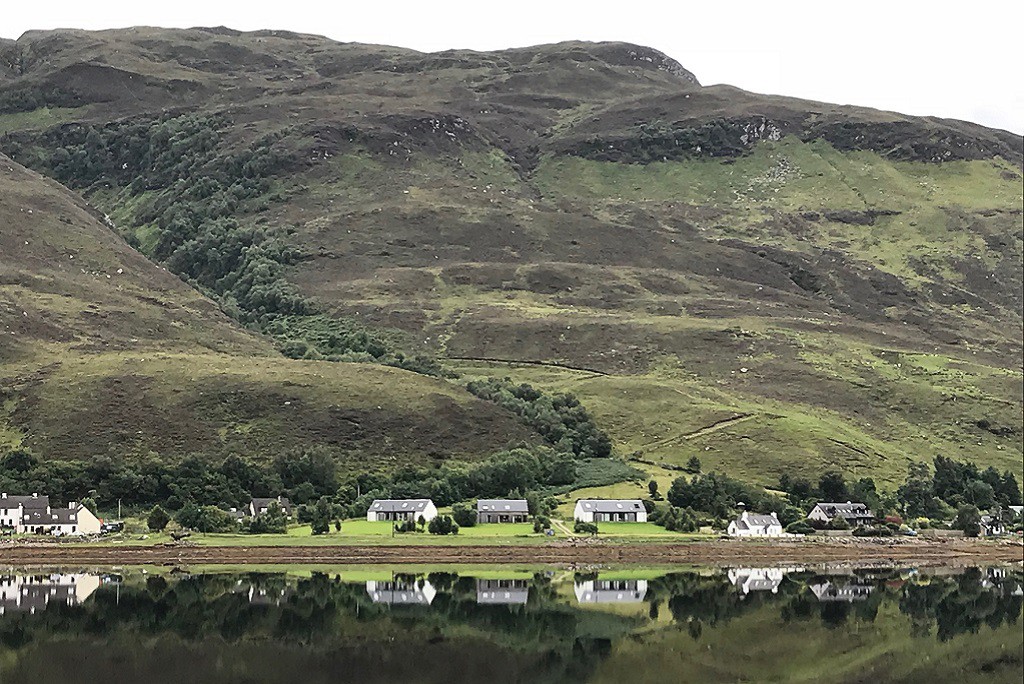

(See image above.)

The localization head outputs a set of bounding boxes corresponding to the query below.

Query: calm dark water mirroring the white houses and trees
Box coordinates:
[0,567,1024,684]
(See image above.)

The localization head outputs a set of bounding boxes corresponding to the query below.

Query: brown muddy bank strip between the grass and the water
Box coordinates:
[0,540,1024,566]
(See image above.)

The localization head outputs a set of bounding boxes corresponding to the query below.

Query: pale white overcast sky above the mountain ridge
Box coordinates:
[0,0,1024,133]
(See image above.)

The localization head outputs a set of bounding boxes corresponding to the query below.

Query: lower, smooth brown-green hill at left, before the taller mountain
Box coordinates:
[0,155,532,468]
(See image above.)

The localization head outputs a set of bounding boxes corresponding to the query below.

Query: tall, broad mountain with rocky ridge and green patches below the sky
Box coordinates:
[0,28,1024,485]
